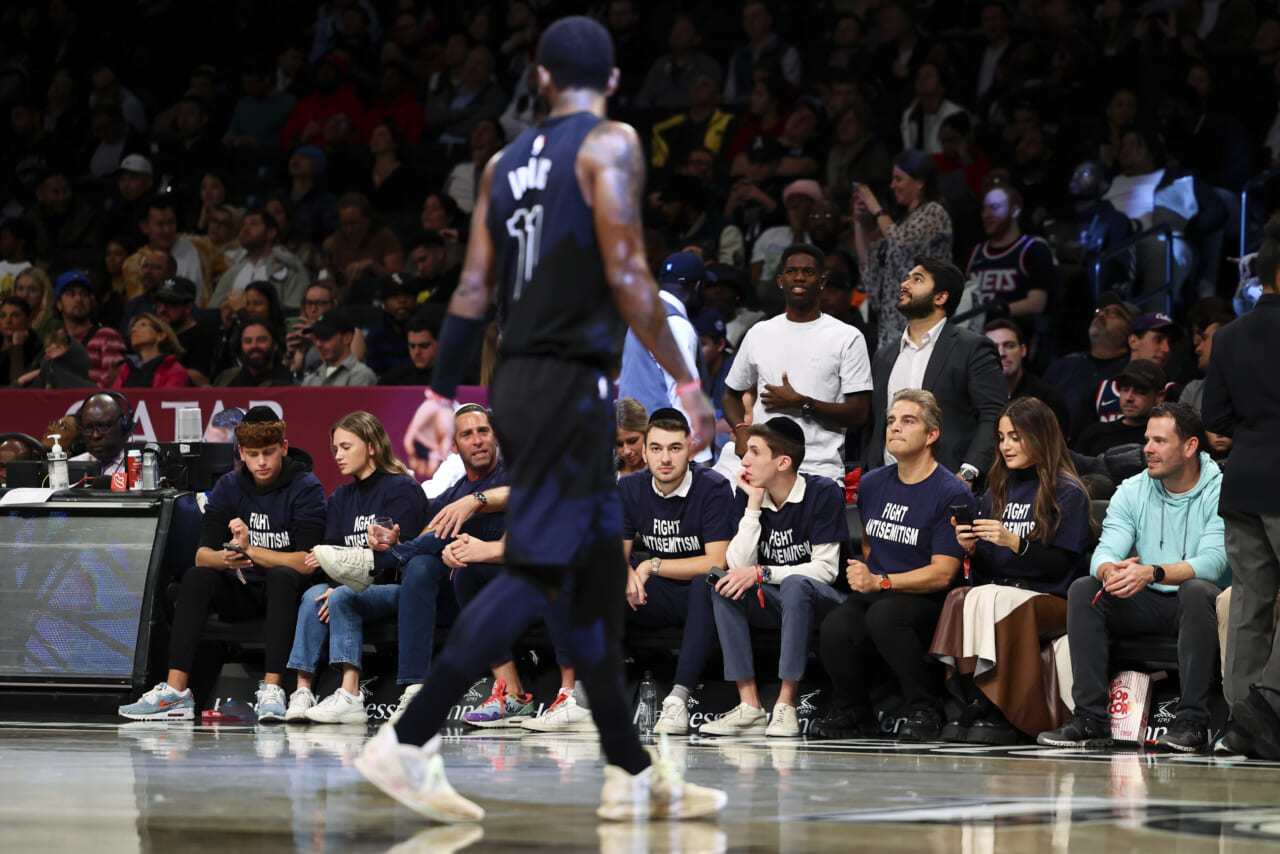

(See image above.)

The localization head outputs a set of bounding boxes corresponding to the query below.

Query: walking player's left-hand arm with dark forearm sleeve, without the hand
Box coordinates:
[431,151,502,399]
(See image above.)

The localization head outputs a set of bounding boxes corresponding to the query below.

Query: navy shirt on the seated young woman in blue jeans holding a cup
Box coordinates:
[324,471,428,548]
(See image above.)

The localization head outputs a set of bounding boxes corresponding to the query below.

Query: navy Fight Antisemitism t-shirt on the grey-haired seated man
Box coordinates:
[858,465,974,575]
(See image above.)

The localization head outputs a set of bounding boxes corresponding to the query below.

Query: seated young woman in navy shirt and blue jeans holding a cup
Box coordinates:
[284,412,428,723]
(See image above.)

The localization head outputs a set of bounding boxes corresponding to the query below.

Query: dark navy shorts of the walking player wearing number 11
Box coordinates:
[490,356,622,586]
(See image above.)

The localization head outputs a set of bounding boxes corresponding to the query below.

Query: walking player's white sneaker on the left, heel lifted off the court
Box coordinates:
[356,723,484,823]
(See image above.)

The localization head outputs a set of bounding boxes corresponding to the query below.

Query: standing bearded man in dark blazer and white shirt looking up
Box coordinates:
[863,256,1009,485]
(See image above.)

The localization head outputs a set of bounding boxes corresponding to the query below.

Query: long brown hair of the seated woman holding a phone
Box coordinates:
[987,397,1088,545]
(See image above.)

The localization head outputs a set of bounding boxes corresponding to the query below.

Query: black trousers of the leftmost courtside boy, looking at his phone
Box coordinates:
[169,566,314,673]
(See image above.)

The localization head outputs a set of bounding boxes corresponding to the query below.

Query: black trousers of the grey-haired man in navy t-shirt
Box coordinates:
[820,590,946,712]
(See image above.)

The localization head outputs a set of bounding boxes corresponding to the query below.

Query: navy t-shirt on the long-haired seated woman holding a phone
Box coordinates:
[975,469,1089,597]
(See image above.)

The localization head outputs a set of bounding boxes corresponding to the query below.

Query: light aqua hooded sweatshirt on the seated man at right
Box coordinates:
[1089,453,1231,593]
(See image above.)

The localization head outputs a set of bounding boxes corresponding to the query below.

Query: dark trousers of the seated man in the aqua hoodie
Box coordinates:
[1066,576,1221,726]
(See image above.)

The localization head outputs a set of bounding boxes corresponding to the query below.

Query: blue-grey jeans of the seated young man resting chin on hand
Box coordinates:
[712,575,845,682]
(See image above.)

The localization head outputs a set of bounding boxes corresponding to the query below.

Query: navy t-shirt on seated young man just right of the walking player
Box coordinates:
[618,466,737,560]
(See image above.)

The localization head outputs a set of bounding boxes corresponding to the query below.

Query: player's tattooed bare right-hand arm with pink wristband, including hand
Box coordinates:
[586,122,716,444]
